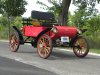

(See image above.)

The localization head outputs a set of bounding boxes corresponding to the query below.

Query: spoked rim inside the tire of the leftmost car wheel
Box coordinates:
[9,34,19,52]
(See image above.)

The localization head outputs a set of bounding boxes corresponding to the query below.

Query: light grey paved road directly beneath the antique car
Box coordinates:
[0,42,100,75]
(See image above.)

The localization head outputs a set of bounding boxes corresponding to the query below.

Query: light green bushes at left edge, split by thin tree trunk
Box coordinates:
[0,16,22,39]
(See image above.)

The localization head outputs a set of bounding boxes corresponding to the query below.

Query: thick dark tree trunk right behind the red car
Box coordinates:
[58,0,71,25]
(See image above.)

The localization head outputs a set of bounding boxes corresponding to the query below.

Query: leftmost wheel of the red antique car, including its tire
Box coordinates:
[9,32,20,52]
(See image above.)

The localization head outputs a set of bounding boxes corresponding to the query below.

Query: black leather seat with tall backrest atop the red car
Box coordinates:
[31,11,55,27]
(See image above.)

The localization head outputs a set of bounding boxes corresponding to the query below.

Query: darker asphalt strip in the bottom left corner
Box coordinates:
[0,57,57,75]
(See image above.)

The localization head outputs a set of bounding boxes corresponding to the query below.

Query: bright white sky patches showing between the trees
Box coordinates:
[23,0,100,17]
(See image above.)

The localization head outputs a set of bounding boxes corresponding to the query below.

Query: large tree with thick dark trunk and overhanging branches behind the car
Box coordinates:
[37,0,100,25]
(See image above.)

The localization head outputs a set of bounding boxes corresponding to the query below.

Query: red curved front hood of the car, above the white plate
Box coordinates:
[50,26,77,39]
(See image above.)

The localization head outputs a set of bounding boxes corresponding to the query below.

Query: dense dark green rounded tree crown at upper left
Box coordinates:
[4,0,27,16]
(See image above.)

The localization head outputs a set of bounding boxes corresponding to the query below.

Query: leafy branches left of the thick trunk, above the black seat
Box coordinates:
[37,0,62,21]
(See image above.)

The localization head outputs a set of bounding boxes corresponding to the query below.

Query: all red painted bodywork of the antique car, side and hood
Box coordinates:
[23,26,77,39]
